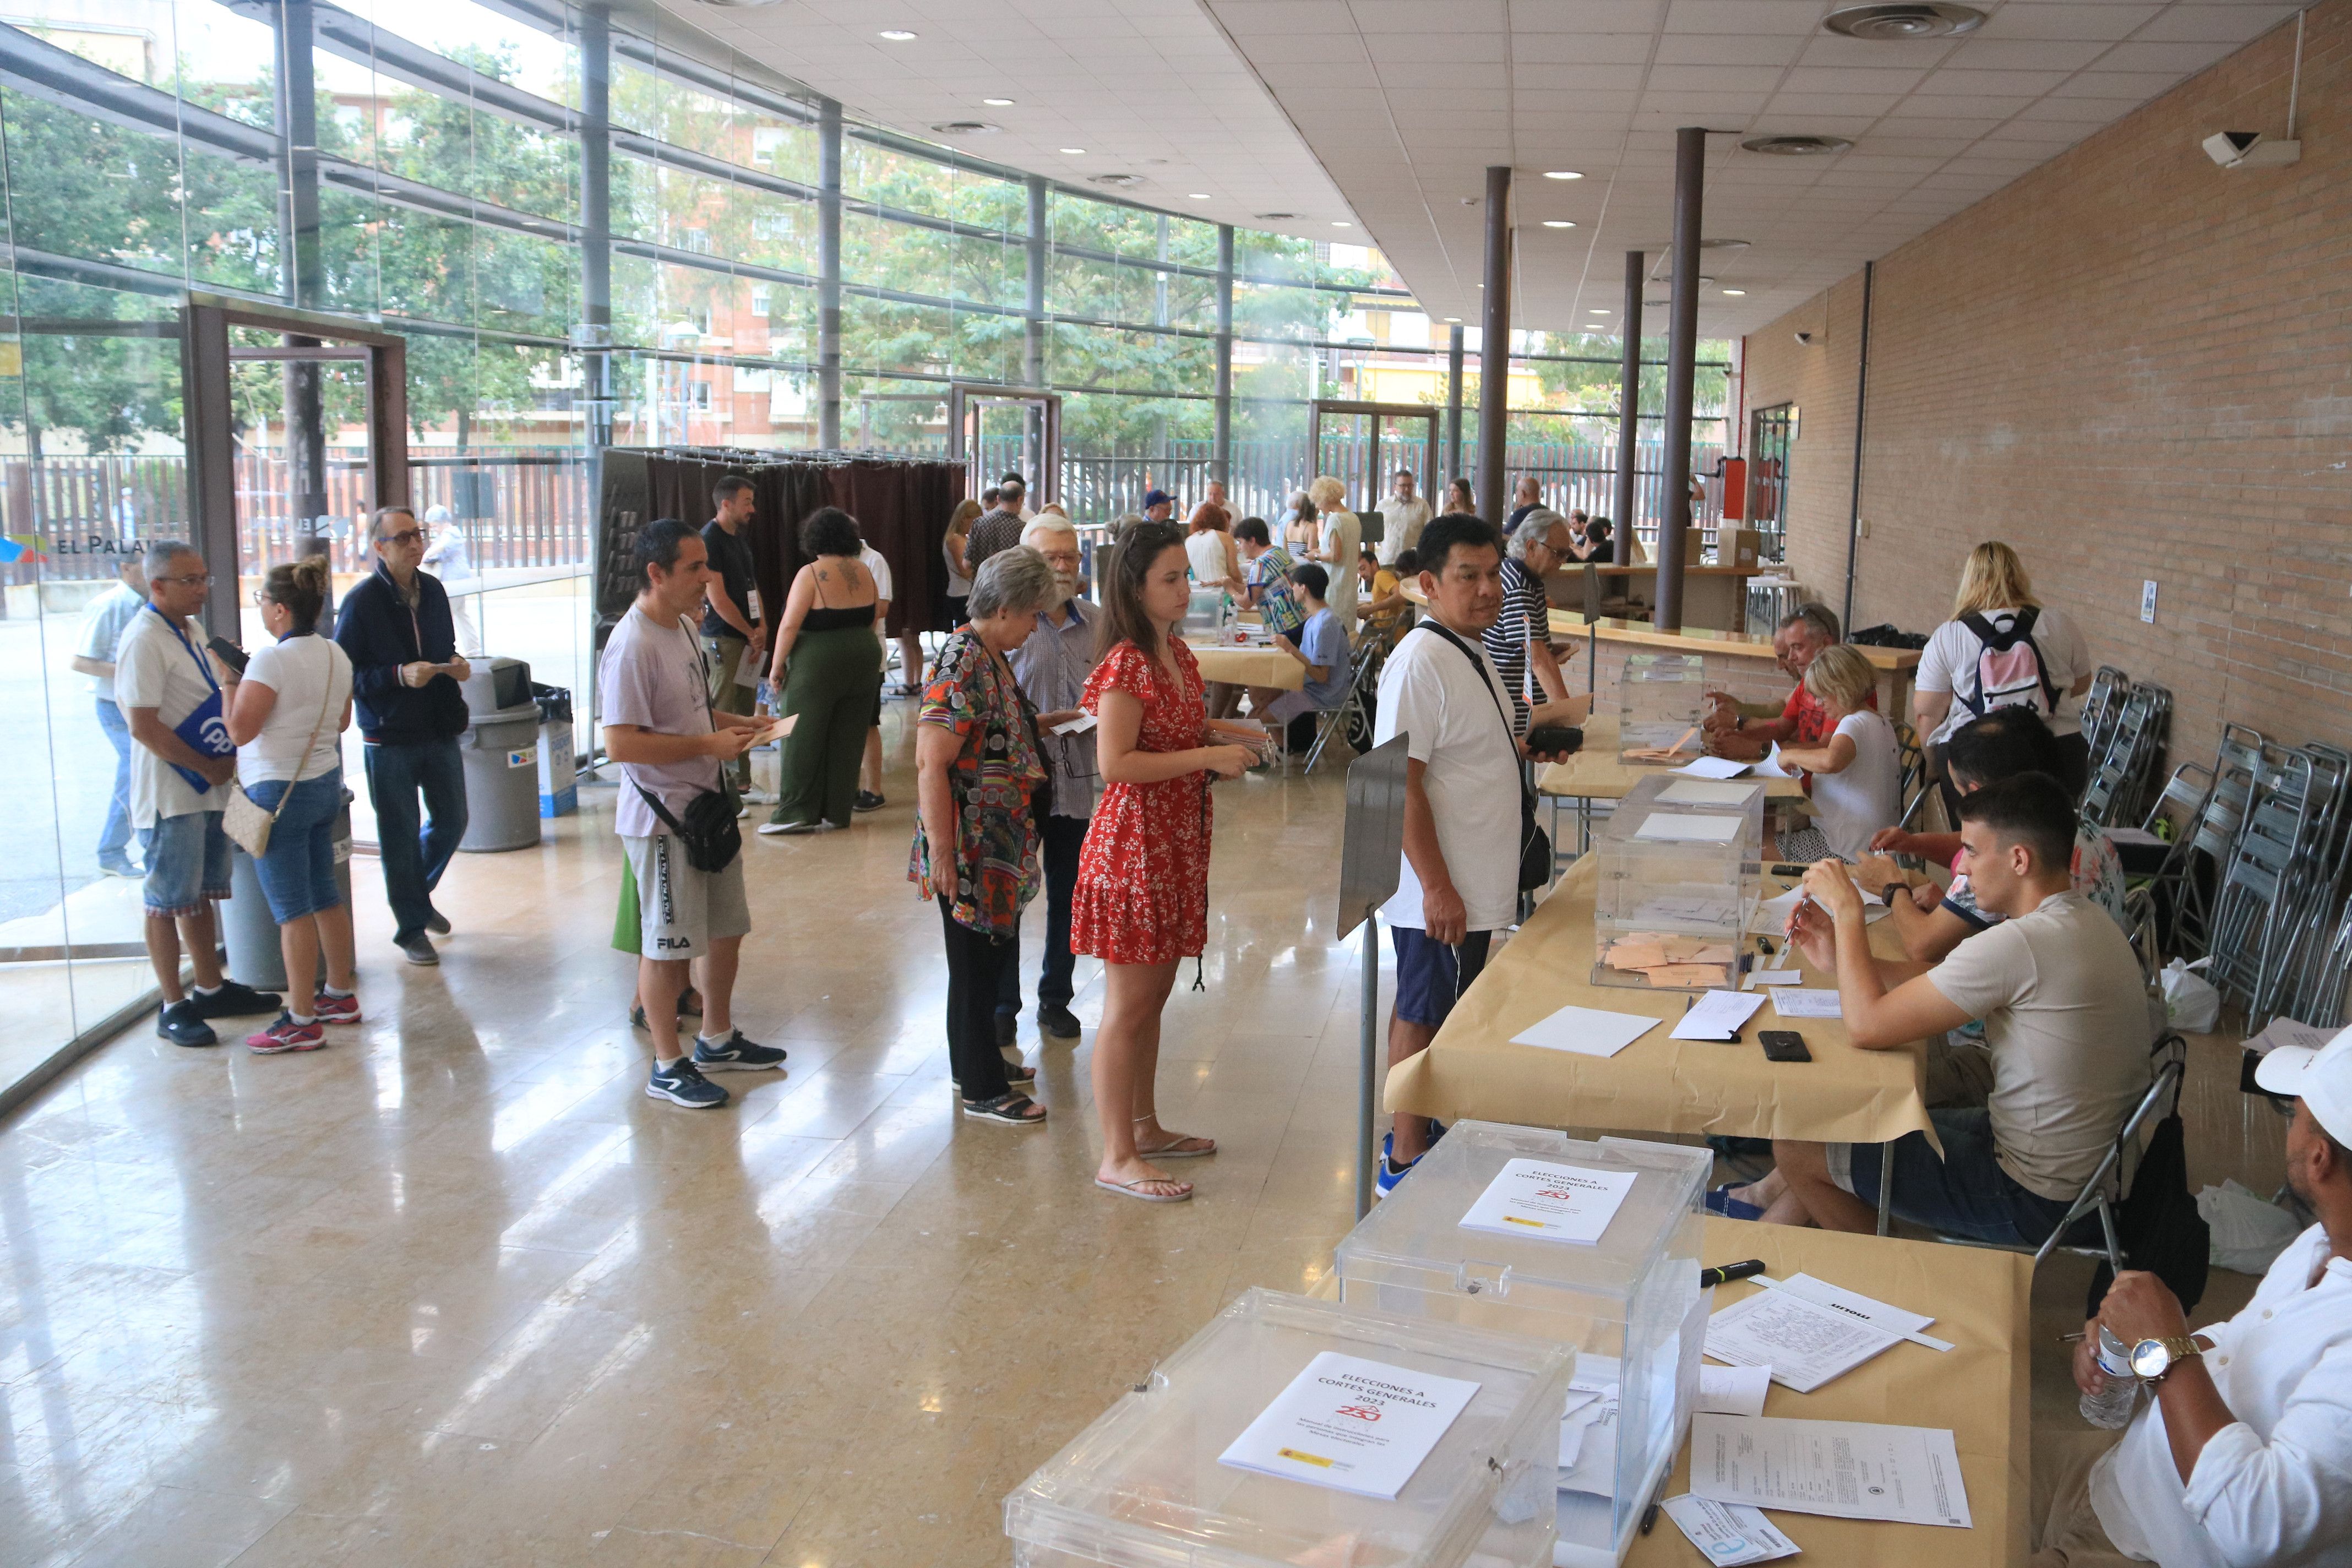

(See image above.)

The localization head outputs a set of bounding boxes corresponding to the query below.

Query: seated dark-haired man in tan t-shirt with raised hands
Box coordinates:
[1707,774,2150,1246]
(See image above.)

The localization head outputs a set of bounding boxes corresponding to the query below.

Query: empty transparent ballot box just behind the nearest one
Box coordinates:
[1333,1121,1712,1568]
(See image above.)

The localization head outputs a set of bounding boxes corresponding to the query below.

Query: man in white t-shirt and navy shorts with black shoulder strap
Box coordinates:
[1371,515,1580,1192]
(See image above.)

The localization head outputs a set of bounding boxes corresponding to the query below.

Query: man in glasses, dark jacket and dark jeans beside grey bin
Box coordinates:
[334,505,473,964]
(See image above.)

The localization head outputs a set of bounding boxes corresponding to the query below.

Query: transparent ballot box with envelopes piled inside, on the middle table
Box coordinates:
[1592,774,1764,990]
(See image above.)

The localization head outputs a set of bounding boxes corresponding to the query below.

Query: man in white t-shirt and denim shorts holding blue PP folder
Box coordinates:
[115,538,277,1046]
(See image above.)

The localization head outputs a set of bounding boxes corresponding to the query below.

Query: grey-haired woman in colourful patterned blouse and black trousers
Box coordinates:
[906,546,1054,1126]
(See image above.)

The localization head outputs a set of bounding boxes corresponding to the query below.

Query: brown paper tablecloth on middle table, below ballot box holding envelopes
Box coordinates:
[1385,856,1934,1142]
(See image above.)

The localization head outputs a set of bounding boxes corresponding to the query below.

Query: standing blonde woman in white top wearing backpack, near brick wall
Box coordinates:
[1912,538,2095,799]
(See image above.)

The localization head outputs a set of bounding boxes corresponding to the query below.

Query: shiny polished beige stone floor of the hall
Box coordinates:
[0,710,2279,1568]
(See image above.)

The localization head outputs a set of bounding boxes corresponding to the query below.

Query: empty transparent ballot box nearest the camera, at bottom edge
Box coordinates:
[1004,1288,1574,1568]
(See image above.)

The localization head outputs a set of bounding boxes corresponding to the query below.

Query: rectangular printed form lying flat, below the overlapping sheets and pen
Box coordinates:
[1691,1419,1973,1531]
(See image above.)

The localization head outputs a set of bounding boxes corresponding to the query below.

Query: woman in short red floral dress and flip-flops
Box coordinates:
[1070,522,1256,1204]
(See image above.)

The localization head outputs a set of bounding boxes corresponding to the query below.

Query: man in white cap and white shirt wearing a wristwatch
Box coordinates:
[2032,1030,2352,1568]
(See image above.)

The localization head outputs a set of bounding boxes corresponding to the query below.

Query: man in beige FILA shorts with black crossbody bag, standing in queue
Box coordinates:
[597,517,783,1109]
